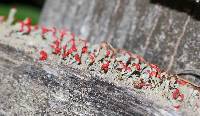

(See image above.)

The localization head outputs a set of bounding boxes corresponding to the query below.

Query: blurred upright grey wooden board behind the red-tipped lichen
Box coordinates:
[40,0,200,75]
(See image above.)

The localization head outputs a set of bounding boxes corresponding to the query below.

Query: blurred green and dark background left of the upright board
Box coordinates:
[0,0,45,24]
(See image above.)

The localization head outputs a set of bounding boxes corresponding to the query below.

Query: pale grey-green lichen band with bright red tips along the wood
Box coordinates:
[0,9,200,113]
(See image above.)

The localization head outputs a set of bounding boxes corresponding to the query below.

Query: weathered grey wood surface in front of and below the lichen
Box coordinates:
[0,40,178,116]
